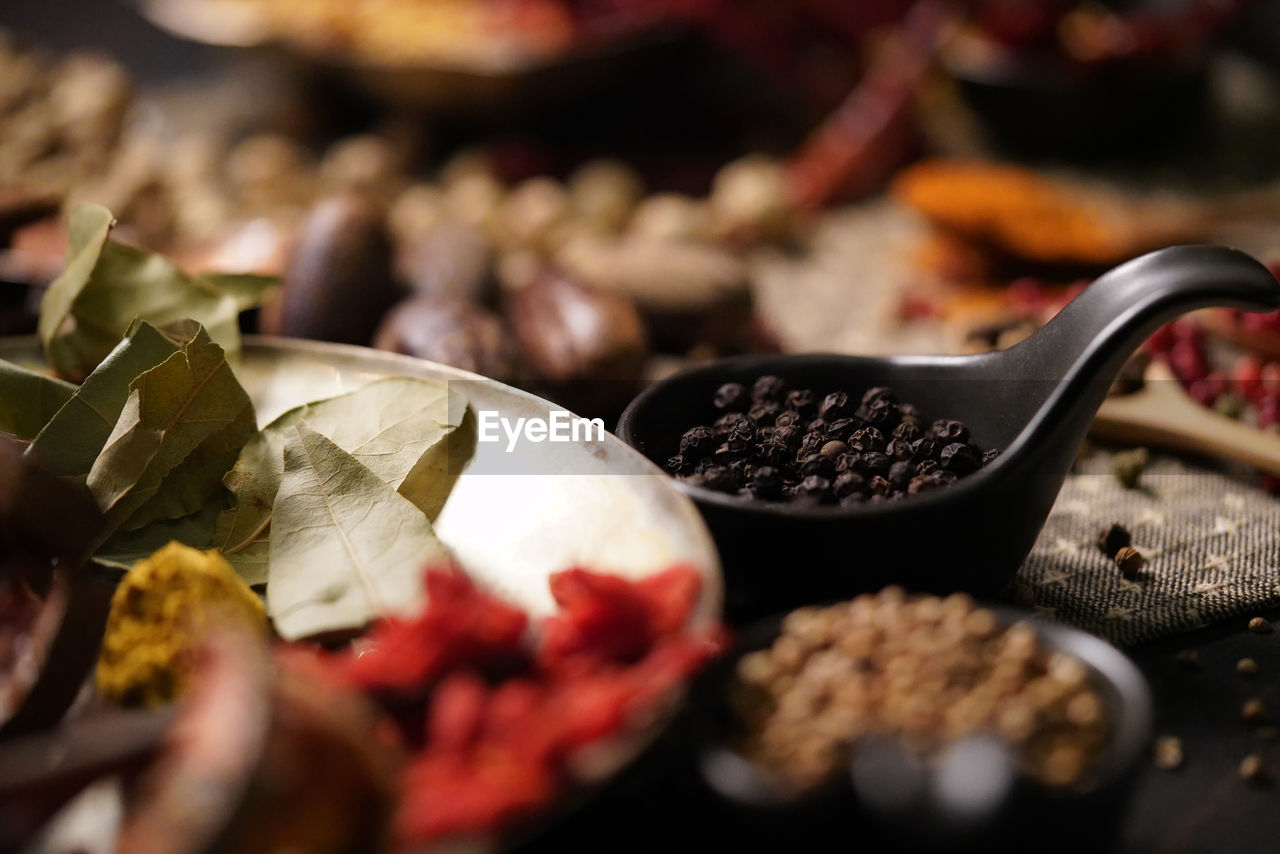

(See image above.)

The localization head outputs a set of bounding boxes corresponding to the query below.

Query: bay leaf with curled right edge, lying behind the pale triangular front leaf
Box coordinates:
[214,376,475,584]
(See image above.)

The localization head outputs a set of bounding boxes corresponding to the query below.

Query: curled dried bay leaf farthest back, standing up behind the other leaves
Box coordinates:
[38,205,243,382]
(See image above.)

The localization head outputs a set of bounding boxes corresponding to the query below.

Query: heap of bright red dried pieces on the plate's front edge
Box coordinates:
[329,567,723,845]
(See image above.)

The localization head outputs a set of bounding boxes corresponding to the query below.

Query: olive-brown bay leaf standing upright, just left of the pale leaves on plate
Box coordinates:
[86,323,257,545]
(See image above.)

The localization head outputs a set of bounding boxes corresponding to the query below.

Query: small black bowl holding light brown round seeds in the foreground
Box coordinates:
[687,608,1152,851]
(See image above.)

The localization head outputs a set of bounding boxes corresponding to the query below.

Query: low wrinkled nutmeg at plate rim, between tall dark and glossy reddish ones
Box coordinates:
[374,294,517,382]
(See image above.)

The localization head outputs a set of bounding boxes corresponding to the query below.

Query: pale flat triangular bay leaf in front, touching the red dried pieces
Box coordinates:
[266,423,448,640]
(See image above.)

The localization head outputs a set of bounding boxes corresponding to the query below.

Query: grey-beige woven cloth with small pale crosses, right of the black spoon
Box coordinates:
[1014,451,1280,644]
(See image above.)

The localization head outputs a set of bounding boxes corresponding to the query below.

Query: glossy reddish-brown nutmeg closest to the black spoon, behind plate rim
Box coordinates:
[507,269,649,414]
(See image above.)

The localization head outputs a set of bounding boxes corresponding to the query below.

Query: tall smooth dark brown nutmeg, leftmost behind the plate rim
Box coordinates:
[270,195,398,344]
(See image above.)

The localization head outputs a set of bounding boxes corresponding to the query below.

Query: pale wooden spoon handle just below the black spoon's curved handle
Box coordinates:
[1092,362,1280,476]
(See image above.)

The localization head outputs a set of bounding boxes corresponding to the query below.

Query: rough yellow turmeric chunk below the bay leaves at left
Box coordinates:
[97,542,266,705]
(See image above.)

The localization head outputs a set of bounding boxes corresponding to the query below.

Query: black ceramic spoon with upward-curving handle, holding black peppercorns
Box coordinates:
[618,246,1280,620]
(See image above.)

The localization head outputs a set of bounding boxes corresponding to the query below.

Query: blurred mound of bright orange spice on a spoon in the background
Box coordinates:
[892,160,1134,264]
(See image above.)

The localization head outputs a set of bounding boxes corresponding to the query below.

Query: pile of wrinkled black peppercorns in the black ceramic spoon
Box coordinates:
[666,376,997,506]
